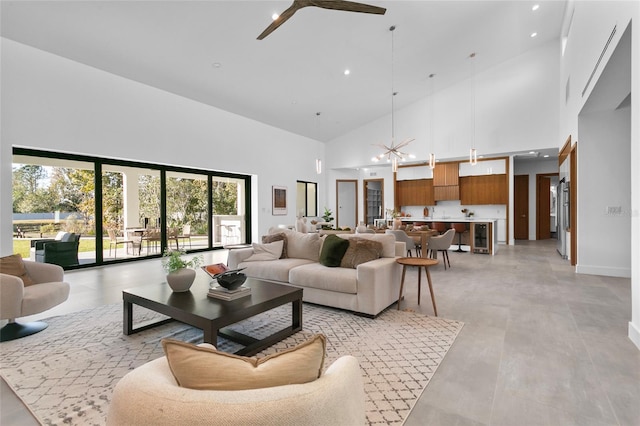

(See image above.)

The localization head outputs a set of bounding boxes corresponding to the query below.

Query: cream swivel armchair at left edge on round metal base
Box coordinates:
[0,260,69,342]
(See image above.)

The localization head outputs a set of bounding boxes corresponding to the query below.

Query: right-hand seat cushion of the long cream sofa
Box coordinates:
[289,263,358,294]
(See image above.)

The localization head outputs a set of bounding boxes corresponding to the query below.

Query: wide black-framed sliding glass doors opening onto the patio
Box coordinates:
[13,148,251,269]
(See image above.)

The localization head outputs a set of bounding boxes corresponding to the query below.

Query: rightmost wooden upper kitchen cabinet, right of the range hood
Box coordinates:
[460,174,509,205]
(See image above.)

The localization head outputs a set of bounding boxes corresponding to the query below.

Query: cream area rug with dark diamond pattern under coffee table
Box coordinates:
[0,303,463,425]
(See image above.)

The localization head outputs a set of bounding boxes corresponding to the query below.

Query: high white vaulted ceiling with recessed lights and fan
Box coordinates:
[1,0,566,141]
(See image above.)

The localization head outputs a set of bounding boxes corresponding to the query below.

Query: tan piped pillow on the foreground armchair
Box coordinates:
[162,334,326,390]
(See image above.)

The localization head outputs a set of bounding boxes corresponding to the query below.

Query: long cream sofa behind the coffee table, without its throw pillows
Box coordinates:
[227,229,405,317]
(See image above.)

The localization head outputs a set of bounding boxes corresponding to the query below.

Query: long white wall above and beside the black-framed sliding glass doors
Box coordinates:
[0,39,326,254]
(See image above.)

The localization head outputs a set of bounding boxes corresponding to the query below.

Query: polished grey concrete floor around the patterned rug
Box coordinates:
[0,240,640,426]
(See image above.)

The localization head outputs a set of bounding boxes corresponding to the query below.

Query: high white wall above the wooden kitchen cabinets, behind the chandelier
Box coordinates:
[326,40,560,168]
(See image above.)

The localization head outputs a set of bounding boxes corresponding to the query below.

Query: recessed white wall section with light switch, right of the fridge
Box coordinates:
[576,107,631,277]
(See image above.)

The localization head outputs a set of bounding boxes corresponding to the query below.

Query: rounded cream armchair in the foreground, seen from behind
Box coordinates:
[107,356,365,426]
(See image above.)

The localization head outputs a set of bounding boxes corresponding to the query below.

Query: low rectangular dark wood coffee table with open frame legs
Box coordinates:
[122,276,302,355]
